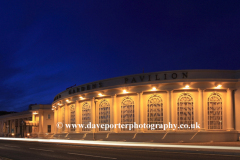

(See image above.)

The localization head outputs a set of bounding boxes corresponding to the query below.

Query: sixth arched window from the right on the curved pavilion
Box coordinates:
[82,102,91,131]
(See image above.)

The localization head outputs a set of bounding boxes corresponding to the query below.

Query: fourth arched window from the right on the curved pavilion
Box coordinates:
[121,97,134,131]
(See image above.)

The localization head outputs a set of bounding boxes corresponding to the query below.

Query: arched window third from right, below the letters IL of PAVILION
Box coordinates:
[148,94,163,130]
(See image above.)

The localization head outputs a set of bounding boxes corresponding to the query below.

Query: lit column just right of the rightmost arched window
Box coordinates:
[226,88,234,131]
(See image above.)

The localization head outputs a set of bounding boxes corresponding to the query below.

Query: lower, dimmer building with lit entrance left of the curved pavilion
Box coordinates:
[0,104,54,137]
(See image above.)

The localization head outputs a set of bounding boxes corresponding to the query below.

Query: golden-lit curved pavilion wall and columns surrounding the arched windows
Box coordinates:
[55,87,235,133]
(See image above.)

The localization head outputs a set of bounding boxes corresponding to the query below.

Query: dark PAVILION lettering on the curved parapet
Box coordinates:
[124,72,188,84]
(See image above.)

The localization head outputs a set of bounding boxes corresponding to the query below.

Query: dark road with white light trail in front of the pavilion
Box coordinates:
[0,137,240,160]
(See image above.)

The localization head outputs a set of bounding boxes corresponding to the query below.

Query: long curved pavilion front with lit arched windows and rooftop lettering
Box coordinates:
[52,70,240,142]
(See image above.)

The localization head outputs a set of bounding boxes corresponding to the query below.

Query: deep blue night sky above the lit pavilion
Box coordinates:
[0,0,240,111]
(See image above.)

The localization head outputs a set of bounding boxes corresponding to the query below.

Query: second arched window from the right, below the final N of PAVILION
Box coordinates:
[177,93,194,129]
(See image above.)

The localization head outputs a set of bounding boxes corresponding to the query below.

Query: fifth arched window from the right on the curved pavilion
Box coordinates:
[99,99,110,131]
